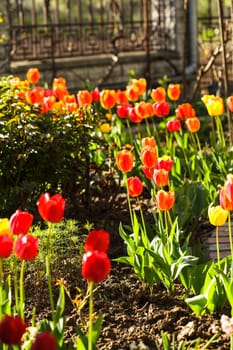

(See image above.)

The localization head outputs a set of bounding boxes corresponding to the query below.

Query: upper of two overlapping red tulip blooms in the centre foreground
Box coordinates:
[84,230,110,252]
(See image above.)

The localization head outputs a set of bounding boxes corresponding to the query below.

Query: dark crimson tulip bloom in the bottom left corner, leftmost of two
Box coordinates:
[0,315,27,345]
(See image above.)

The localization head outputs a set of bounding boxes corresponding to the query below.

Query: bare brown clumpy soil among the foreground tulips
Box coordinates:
[25,193,229,350]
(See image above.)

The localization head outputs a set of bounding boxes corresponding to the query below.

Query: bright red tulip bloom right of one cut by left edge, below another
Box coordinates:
[14,235,39,260]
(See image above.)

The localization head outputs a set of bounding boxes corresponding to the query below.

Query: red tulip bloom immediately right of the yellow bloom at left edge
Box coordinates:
[10,209,34,235]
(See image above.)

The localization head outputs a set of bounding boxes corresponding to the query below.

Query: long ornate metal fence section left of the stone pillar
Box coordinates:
[7,0,176,61]
